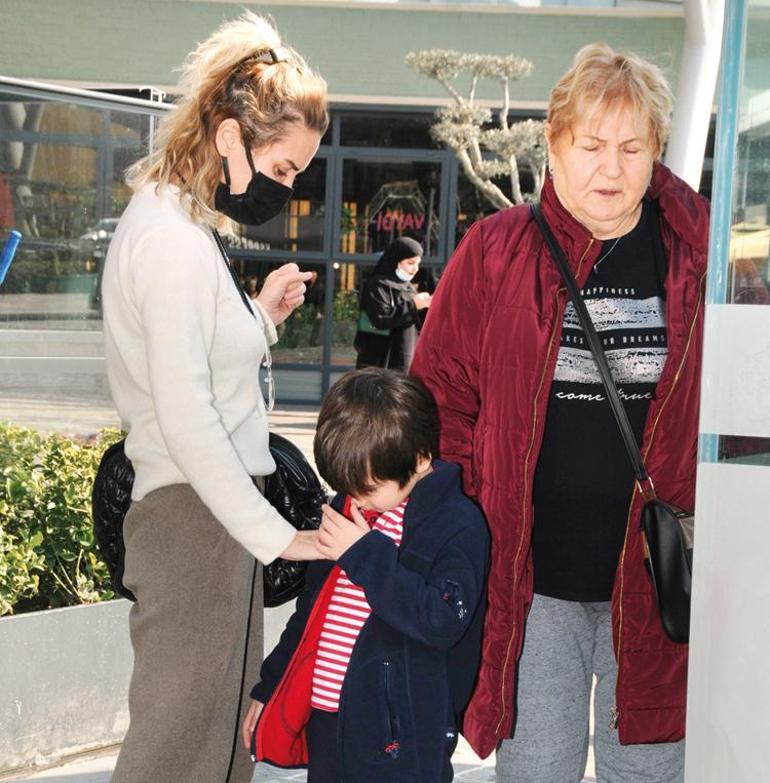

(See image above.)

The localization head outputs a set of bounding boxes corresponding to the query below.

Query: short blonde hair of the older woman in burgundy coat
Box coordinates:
[547,43,674,158]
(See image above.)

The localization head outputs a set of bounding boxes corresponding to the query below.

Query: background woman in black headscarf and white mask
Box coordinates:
[355,237,431,370]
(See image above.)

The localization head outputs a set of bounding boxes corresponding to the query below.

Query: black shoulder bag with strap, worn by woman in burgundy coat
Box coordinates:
[530,204,695,644]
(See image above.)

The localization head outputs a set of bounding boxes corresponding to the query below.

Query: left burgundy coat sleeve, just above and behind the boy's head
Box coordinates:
[409,223,484,497]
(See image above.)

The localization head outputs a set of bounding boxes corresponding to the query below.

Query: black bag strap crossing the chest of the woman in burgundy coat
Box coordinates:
[530,204,654,492]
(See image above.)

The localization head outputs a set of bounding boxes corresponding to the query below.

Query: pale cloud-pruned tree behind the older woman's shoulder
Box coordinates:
[406,49,546,209]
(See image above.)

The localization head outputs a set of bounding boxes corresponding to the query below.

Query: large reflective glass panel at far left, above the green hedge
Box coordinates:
[0,92,154,436]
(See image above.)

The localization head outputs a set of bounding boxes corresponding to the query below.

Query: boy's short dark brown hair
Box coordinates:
[313,367,439,495]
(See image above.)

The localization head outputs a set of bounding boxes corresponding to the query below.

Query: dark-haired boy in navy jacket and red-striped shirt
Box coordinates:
[243,368,489,783]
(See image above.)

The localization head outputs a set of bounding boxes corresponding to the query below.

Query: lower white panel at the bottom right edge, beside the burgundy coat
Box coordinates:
[686,462,770,783]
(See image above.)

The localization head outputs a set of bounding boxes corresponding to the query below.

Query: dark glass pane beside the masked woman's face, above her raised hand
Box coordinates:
[238,158,326,253]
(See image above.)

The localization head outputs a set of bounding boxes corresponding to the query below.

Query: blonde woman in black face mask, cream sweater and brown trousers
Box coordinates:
[103,13,328,783]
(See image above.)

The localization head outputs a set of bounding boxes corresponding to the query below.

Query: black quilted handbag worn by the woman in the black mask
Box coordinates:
[91,231,327,607]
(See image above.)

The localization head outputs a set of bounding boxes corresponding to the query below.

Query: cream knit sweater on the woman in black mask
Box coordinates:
[102,185,295,563]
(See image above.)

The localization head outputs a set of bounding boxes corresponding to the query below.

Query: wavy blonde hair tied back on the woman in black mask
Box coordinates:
[126,11,329,225]
